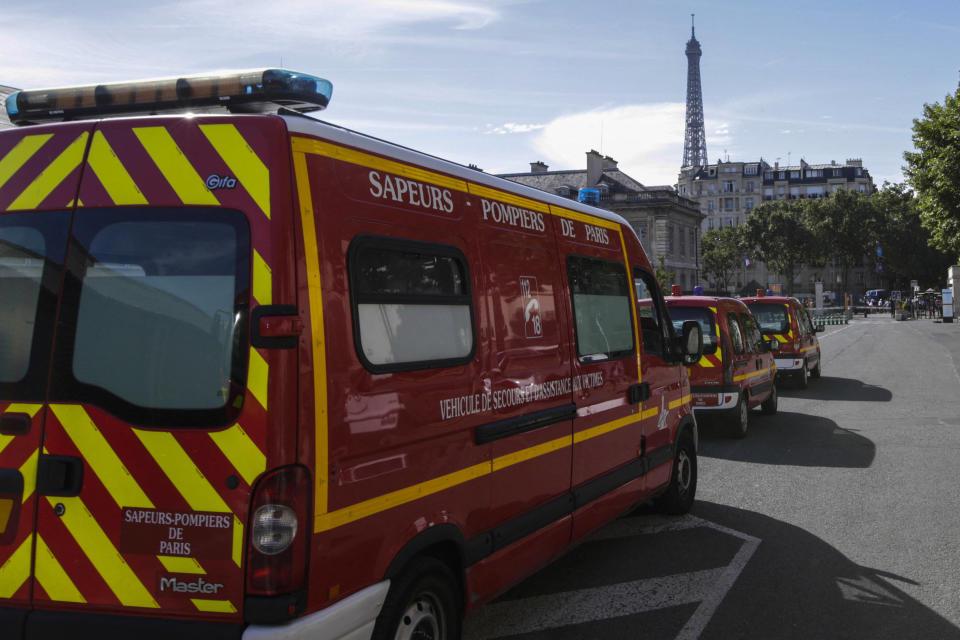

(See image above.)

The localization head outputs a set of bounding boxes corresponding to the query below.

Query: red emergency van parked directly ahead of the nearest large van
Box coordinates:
[666,292,779,438]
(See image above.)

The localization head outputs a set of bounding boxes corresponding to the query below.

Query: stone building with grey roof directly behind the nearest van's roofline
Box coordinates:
[500,150,701,291]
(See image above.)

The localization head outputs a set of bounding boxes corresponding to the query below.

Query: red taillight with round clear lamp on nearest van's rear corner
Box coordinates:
[247,467,311,595]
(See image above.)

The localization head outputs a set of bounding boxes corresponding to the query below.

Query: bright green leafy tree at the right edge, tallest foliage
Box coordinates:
[903,87,960,259]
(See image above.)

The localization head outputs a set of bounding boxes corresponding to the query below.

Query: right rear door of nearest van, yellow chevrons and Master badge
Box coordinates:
[0,117,296,625]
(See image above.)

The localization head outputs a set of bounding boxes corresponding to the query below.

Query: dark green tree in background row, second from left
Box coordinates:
[744,200,821,296]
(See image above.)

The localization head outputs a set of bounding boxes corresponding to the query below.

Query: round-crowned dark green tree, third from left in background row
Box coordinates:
[805,190,881,291]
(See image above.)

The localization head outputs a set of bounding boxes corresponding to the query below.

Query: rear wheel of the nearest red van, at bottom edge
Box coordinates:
[373,557,462,640]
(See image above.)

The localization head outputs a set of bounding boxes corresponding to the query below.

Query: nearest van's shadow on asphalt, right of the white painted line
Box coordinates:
[677,502,960,640]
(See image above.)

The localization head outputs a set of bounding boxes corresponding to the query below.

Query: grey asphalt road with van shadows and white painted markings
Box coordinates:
[465,316,960,640]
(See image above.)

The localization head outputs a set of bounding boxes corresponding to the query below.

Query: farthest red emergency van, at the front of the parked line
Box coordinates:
[742,289,823,389]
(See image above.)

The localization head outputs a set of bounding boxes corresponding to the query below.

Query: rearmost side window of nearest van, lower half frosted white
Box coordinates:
[348,236,476,373]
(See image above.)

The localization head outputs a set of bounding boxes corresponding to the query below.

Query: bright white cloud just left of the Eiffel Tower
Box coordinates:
[533,102,684,185]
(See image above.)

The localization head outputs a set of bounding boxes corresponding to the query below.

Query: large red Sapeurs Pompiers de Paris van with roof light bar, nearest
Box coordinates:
[0,70,700,640]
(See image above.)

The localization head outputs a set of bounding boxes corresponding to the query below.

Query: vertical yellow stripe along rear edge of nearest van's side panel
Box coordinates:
[293,152,331,531]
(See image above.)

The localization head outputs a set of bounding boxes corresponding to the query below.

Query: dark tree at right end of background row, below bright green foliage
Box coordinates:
[870,182,953,289]
